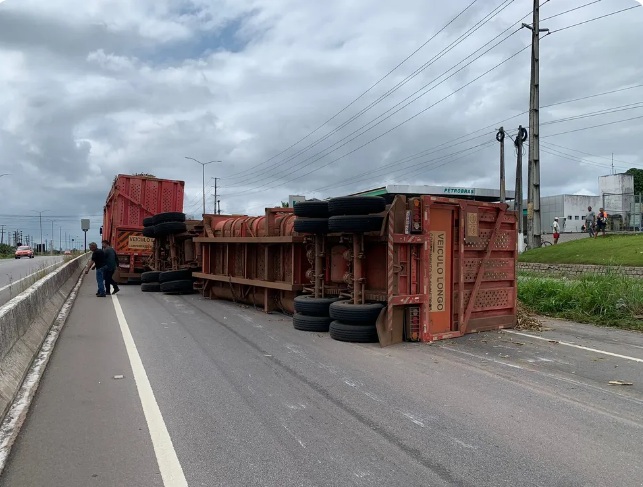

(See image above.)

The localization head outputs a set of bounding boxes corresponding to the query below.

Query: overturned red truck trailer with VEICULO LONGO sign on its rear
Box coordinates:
[194,195,517,346]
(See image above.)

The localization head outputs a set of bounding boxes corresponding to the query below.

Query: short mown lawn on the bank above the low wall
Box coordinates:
[518,234,643,267]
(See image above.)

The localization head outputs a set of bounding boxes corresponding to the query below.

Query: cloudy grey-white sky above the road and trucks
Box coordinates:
[0,0,643,247]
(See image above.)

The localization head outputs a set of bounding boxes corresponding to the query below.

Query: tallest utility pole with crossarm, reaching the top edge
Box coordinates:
[522,0,549,248]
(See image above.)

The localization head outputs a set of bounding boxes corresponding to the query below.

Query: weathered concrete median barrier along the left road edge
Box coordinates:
[0,254,89,422]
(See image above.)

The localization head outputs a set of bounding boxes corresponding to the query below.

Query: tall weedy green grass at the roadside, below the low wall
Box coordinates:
[518,272,643,331]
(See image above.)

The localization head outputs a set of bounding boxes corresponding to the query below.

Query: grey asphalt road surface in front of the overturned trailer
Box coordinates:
[0,276,643,487]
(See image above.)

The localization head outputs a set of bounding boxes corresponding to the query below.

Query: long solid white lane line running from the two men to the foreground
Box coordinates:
[112,295,188,487]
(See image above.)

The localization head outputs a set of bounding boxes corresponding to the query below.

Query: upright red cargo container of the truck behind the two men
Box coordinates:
[101,174,185,283]
